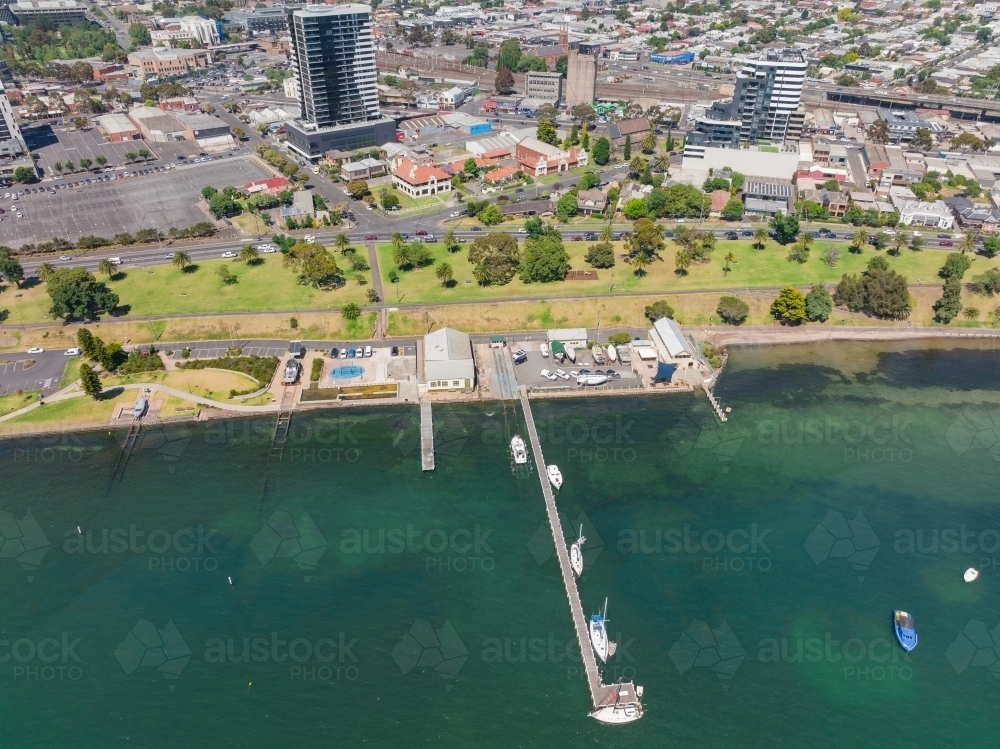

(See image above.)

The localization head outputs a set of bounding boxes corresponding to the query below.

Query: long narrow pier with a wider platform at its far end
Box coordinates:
[520,386,642,723]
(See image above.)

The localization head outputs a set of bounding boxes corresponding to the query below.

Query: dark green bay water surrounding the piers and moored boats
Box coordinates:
[0,344,1000,747]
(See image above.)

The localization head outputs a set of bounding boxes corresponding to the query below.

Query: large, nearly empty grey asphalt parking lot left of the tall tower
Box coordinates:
[0,156,268,247]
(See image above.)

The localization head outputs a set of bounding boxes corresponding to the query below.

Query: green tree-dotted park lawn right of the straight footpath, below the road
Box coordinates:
[378,235,964,304]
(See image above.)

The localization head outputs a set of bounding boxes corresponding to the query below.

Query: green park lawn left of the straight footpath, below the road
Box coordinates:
[3,254,371,323]
